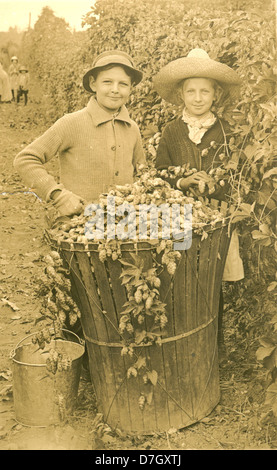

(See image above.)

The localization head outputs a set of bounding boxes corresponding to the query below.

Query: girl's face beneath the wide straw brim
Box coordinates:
[181,78,215,118]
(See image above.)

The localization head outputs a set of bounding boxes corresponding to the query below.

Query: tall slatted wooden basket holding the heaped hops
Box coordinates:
[45,199,230,433]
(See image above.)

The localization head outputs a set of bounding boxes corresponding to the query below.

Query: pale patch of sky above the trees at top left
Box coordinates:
[0,0,94,32]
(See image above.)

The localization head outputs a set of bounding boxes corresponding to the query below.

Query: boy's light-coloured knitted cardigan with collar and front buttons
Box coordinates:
[14,97,145,202]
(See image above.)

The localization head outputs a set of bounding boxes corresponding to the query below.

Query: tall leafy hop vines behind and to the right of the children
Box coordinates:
[13,0,277,413]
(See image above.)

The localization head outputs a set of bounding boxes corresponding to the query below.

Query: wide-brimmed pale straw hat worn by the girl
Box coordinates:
[153,48,241,105]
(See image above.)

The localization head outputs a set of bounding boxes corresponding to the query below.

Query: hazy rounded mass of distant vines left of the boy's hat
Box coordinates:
[21,7,91,114]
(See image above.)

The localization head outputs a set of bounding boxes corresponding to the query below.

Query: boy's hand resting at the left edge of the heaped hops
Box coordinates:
[51,189,85,216]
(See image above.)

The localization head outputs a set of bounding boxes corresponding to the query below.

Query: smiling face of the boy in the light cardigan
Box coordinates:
[90,66,132,114]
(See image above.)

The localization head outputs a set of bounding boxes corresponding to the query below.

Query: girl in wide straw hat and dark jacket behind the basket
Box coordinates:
[153,49,244,356]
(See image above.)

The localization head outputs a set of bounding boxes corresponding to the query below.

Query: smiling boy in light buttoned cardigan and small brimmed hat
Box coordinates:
[14,50,145,216]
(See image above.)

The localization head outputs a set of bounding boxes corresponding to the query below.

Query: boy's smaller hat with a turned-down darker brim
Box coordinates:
[83,49,143,93]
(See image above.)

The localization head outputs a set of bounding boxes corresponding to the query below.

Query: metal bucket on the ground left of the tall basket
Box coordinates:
[11,330,84,427]
